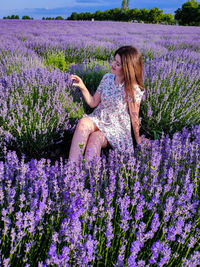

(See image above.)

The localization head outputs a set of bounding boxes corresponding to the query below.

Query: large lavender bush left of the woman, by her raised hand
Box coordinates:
[0,68,83,156]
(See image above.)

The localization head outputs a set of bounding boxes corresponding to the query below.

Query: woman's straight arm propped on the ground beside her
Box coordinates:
[128,101,142,145]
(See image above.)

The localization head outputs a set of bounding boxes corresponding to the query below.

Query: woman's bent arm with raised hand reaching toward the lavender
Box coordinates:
[71,75,101,108]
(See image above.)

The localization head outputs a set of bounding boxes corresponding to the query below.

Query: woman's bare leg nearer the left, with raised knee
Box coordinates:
[69,117,98,163]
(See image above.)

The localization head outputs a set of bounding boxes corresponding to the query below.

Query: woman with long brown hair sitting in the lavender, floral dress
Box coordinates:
[69,46,147,162]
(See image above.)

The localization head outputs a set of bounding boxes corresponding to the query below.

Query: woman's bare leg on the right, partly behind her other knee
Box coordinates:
[85,130,109,162]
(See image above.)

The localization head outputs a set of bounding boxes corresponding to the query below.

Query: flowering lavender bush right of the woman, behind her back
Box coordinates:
[141,58,200,139]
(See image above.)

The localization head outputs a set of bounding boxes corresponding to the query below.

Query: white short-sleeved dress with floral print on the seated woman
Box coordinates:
[83,73,144,153]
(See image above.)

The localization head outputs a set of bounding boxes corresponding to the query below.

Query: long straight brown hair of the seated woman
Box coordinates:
[114,46,144,103]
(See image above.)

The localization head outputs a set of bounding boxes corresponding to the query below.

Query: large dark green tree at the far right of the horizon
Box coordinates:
[175,0,200,26]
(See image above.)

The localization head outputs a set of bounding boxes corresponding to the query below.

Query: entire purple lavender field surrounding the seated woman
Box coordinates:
[0,20,200,267]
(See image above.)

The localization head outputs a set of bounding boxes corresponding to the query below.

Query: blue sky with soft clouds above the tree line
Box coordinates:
[0,0,187,19]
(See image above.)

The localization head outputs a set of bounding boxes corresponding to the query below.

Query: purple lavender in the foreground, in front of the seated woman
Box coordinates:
[0,127,200,267]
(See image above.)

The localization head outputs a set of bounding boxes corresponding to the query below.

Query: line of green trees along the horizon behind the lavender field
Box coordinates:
[1,0,200,26]
